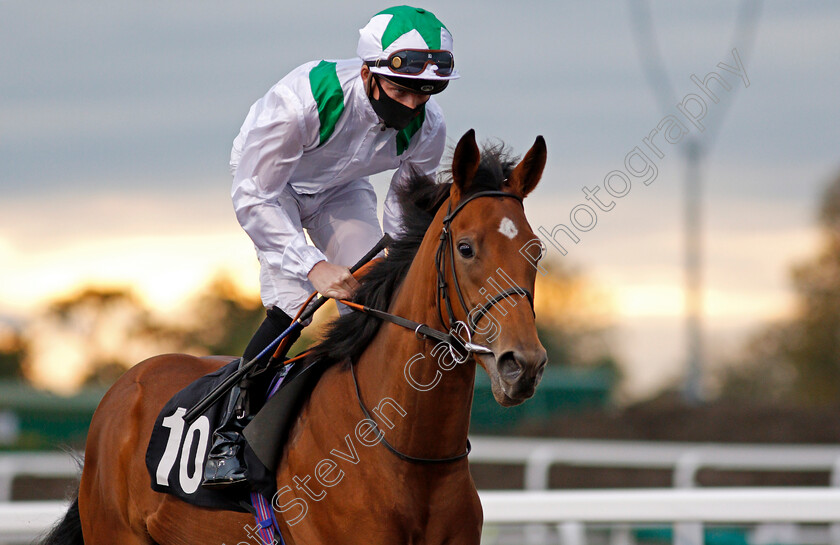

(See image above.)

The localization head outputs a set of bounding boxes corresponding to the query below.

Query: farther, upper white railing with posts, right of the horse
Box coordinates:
[470,437,840,545]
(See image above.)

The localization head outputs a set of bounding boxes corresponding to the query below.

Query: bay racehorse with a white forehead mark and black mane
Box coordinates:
[43,130,546,545]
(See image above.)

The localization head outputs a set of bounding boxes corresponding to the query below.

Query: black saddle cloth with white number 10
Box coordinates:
[146,360,322,512]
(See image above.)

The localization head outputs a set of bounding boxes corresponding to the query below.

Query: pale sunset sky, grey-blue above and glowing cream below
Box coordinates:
[0,0,840,398]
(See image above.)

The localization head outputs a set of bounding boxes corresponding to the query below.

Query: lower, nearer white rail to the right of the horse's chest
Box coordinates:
[479,487,840,545]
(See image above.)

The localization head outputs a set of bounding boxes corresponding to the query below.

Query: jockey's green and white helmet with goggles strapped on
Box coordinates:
[356,6,460,92]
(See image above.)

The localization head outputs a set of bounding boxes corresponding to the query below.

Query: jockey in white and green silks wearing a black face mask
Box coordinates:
[202,6,458,487]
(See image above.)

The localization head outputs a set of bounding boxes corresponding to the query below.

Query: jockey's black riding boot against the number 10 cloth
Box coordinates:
[201,307,300,488]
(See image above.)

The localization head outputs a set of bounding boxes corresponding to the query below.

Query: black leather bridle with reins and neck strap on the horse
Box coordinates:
[342,191,534,464]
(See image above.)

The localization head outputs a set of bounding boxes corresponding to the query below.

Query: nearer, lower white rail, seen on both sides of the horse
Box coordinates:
[0,487,840,545]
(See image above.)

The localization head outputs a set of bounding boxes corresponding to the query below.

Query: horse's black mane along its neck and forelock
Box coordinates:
[308,144,516,364]
